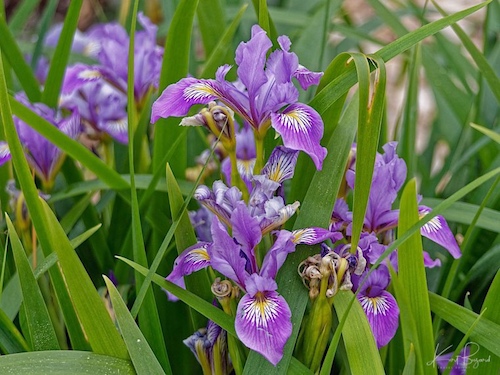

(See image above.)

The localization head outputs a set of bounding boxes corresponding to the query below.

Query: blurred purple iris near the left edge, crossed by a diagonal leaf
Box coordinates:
[0,94,81,189]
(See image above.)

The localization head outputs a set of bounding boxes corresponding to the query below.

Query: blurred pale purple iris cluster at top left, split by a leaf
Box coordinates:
[61,14,163,143]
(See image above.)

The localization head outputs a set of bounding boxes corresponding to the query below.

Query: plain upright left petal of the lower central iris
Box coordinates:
[209,218,248,290]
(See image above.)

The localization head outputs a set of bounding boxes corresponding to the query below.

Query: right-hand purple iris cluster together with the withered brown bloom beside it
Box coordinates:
[299,142,461,356]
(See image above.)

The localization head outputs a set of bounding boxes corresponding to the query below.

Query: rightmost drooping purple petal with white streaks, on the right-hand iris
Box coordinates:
[418,206,462,259]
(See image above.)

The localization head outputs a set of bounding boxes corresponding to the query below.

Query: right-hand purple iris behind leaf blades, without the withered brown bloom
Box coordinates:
[324,142,460,347]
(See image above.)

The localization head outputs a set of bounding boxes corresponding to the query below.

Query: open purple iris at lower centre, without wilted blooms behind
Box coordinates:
[167,204,331,365]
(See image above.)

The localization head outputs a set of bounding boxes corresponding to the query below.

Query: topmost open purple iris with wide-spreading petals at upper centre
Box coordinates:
[151,25,326,169]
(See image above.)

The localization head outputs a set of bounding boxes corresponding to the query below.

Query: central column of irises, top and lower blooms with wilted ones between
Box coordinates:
[151,25,336,365]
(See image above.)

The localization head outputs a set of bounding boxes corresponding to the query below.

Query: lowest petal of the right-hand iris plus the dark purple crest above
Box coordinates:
[353,265,399,348]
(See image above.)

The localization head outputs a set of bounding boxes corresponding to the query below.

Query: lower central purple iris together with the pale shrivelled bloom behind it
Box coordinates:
[167,148,333,365]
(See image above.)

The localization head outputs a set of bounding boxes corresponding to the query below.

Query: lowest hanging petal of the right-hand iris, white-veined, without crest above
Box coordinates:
[358,290,399,348]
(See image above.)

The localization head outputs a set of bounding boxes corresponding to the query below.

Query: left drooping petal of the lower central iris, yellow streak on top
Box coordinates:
[166,242,211,301]
